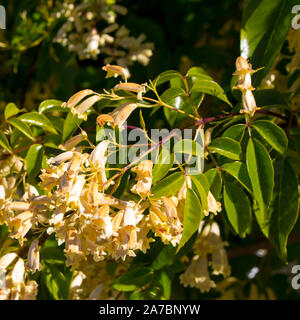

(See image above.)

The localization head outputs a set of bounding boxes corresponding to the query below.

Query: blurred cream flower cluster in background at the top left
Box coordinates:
[53,0,153,66]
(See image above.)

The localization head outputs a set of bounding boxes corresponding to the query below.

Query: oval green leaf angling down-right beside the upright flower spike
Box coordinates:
[251,120,288,155]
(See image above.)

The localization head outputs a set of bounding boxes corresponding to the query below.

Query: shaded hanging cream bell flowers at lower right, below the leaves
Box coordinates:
[180,222,231,292]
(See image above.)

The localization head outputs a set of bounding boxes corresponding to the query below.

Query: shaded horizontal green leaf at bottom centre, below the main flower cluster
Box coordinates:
[112,268,153,291]
